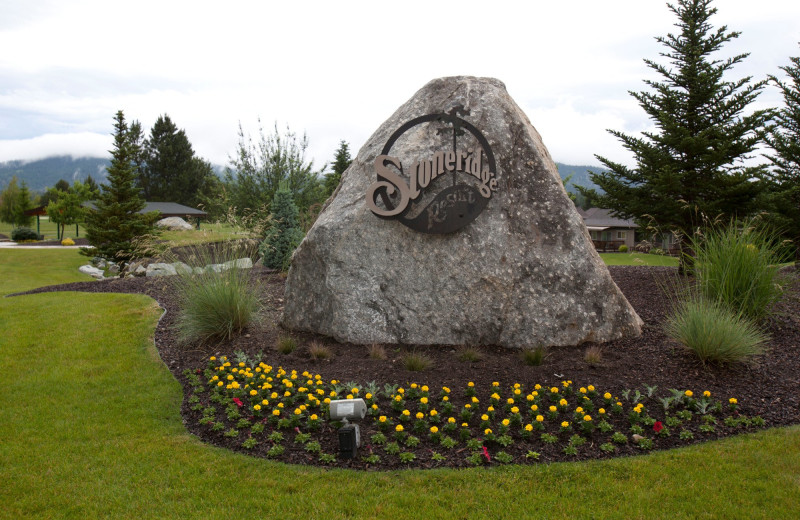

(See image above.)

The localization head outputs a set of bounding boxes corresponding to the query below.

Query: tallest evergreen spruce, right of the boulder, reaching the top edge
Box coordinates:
[579,0,769,264]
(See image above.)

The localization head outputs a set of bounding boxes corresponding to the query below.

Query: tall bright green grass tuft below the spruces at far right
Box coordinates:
[692,220,781,321]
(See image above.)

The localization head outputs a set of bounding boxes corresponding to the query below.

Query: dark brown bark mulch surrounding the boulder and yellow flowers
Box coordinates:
[14,266,800,469]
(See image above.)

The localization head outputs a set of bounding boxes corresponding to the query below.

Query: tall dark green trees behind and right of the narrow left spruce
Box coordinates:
[138,114,219,207]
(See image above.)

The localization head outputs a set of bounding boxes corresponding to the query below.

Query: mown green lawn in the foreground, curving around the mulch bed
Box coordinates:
[0,250,800,520]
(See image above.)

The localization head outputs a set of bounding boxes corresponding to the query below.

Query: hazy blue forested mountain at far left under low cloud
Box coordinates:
[0,155,109,192]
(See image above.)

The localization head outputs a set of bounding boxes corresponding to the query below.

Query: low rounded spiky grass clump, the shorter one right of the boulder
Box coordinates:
[664,293,767,363]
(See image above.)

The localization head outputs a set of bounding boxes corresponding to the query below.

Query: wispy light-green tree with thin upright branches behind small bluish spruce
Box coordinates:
[223,123,325,216]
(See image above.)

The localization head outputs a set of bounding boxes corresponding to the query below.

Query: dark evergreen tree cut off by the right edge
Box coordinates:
[766,46,800,264]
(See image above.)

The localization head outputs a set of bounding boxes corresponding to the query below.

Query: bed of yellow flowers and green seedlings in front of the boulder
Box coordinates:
[184,356,765,468]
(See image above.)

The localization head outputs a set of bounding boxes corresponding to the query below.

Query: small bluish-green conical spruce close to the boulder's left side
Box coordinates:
[259,181,303,271]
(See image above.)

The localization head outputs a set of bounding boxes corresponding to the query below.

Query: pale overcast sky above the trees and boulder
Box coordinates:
[0,0,800,171]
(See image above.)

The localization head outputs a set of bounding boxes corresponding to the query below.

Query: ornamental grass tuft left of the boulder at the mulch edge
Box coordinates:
[173,245,260,343]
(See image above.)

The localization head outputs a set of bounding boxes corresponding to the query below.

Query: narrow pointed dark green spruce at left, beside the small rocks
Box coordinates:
[83,110,157,262]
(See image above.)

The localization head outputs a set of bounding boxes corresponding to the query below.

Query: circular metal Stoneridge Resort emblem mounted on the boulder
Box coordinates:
[367,106,497,234]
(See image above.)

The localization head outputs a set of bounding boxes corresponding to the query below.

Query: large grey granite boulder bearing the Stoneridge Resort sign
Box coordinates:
[283,77,641,348]
